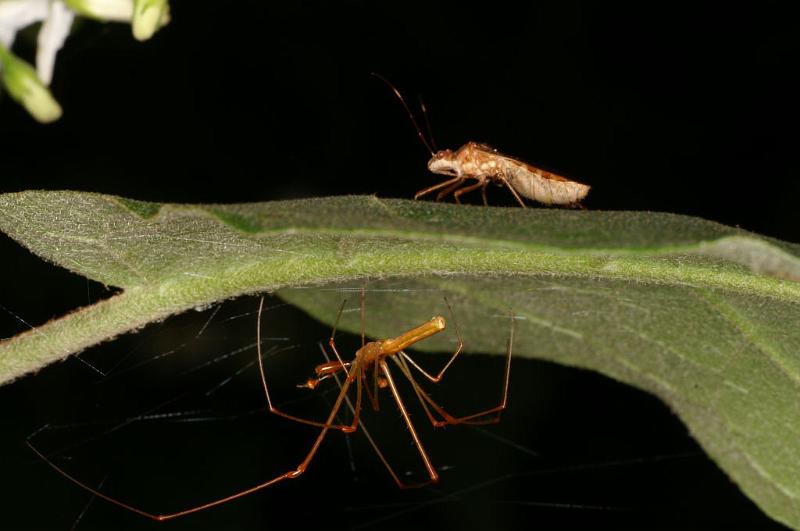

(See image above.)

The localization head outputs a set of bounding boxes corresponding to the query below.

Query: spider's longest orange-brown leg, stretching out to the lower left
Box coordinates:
[27,362,361,522]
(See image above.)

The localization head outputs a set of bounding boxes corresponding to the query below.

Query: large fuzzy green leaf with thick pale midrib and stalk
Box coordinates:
[0,192,800,527]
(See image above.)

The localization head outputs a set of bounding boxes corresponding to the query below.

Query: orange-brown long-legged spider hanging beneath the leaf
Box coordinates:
[27,290,515,521]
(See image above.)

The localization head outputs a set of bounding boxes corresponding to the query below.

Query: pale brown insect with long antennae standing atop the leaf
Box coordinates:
[372,73,591,208]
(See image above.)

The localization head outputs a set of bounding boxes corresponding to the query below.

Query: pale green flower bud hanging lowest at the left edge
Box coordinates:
[0,44,61,123]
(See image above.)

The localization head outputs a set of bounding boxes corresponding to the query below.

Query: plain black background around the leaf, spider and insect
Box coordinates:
[0,1,800,529]
